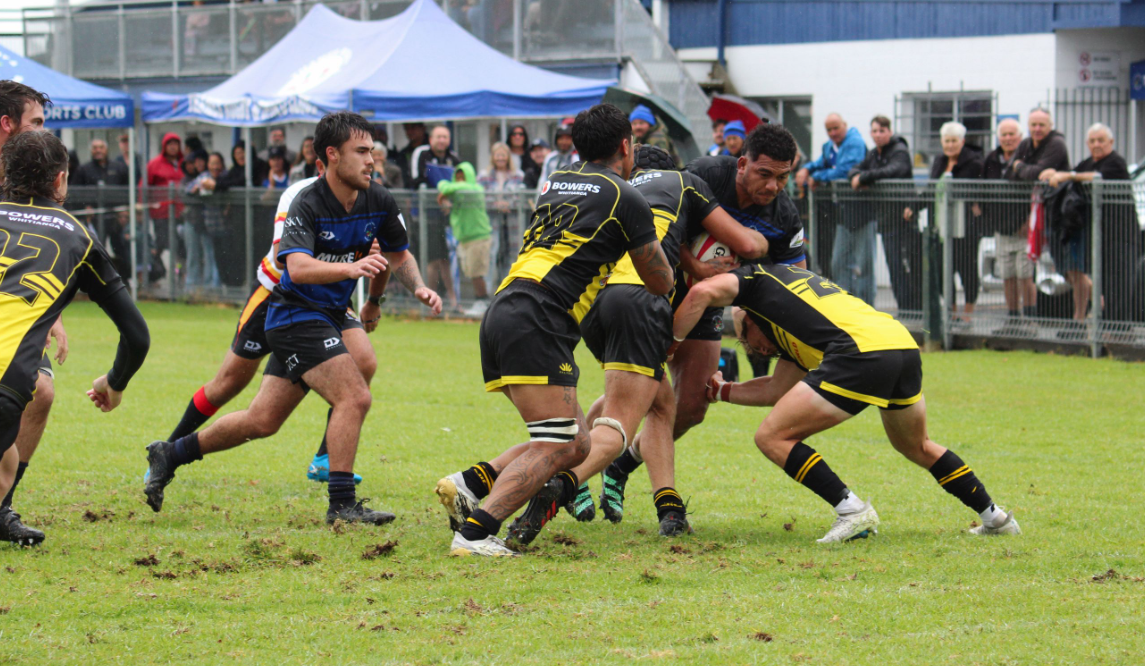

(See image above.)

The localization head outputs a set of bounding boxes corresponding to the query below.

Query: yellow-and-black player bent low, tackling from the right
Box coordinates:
[672,264,1020,544]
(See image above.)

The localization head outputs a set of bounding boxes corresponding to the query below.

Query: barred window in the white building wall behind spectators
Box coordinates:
[895,90,995,167]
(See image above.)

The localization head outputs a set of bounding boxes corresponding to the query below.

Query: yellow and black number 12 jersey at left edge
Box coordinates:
[0,199,124,403]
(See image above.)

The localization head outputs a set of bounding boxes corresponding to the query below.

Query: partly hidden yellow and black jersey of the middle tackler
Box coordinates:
[608,169,719,285]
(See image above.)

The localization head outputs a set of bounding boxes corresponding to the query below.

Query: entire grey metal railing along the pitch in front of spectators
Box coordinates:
[68,180,1145,355]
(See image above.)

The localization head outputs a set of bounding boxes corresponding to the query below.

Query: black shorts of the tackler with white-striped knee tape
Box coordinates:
[481,279,581,391]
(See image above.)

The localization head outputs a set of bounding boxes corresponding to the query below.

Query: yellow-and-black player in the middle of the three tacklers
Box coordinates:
[561,145,767,540]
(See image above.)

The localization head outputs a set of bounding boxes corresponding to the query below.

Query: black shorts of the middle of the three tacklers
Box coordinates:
[581,285,672,381]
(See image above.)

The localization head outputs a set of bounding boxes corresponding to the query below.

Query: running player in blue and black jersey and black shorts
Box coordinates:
[144,112,441,525]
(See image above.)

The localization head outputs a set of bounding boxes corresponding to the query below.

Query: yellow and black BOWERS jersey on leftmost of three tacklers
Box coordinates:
[497,161,656,323]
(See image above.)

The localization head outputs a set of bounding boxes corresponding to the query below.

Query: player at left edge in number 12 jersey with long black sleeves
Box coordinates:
[0,132,150,539]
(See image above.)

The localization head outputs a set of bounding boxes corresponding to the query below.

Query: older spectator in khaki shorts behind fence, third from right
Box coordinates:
[972,118,1037,335]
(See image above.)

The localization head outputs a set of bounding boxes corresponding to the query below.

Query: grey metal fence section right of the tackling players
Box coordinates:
[798,179,1145,356]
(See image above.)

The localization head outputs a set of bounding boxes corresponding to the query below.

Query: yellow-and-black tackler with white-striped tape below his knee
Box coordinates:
[436,104,673,556]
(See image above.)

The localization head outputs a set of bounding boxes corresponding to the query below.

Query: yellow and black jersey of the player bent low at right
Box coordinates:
[732,263,918,371]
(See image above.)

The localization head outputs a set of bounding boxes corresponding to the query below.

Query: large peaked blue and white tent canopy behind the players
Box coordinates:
[143,0,615,127]
